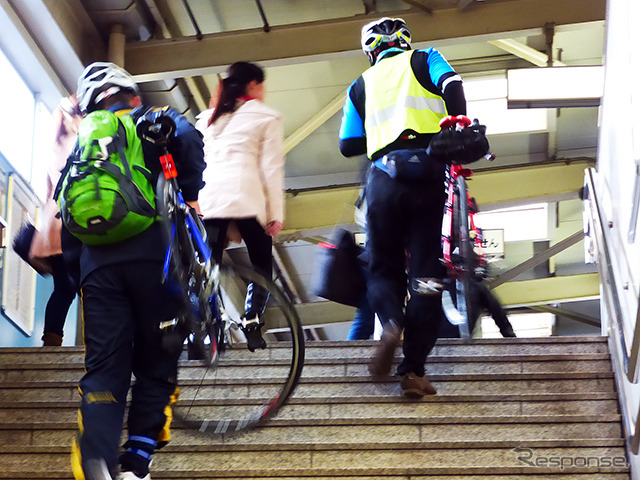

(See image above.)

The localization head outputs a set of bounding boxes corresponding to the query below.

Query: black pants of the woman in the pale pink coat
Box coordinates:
[204,218,273,280]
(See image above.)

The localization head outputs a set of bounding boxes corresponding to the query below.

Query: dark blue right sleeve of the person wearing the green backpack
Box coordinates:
[166,107,206,202]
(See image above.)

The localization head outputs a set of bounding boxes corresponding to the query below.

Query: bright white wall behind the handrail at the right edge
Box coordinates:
[596,0,640,479]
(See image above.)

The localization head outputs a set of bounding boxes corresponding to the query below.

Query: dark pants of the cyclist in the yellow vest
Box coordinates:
[366,166,446,376]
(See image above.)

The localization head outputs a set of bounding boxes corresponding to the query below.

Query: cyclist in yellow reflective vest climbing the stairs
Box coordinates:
[339,17,466,398]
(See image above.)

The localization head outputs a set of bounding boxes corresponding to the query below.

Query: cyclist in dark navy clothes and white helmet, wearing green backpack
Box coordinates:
[63,62,205,480]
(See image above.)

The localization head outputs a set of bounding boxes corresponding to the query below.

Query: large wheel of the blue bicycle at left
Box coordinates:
[173,265,304,435]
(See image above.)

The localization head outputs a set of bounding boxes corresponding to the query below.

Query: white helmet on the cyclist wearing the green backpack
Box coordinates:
[76,62,140,113]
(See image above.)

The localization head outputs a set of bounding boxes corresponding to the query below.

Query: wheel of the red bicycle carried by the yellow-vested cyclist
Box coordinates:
[453,176,476,338]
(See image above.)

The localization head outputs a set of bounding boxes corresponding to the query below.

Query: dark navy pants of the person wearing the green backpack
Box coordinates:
[79,261,185,478]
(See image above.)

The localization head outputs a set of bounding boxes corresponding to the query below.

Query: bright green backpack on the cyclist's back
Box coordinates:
[57,110,157,245]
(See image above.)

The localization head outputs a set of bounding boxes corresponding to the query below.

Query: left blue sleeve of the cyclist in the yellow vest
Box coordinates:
[338,77,367,157]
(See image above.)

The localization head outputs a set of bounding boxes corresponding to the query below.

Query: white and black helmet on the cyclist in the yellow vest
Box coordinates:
[360,17,411,65]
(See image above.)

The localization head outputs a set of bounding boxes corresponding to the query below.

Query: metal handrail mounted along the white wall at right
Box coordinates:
[585,168,640,455]
